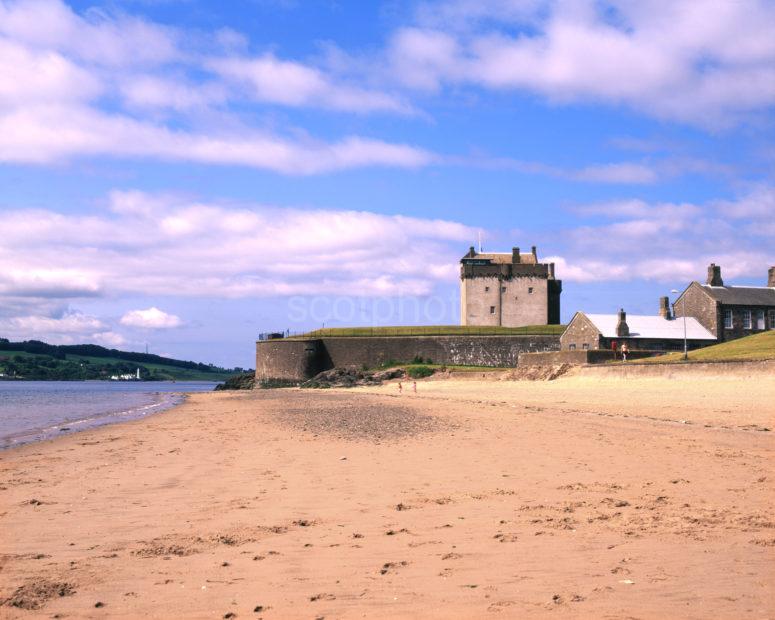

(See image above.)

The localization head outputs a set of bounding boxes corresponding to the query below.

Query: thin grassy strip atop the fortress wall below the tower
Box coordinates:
[292,325,565,338]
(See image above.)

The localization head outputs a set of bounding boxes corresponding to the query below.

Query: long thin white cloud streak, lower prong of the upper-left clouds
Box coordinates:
[0,105,435,174]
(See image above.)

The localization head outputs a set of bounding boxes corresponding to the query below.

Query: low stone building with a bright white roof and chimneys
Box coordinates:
[560,306,716,351]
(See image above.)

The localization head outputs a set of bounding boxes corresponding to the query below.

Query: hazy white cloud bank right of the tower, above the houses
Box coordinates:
[549,185,775,284]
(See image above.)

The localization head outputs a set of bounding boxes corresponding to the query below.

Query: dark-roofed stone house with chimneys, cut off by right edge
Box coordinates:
[673,263,775,342]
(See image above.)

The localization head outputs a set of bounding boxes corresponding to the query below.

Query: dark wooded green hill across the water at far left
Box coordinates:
[0,338,249,381]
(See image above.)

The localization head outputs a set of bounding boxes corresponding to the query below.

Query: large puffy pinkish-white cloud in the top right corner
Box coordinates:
[388,0,775,125]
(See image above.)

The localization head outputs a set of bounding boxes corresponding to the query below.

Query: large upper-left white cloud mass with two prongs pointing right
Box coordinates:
[0,0,434,174]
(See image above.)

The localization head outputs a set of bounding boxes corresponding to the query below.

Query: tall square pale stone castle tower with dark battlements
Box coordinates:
[460,246,562,327]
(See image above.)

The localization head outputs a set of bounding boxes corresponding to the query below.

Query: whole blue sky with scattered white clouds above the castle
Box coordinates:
[0,0,775,367]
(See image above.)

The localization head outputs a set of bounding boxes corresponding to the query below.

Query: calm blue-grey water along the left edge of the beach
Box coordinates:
[0,381,216,449]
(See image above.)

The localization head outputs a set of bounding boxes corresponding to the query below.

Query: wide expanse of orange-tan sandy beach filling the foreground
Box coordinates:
[0,374,775,619]
